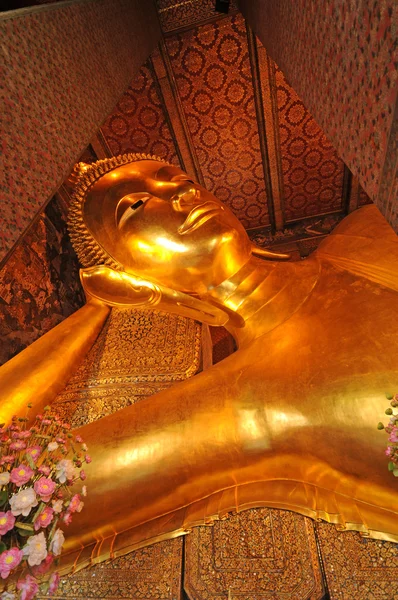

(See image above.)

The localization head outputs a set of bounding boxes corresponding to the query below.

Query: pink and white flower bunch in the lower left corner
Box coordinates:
[0,405,91,600]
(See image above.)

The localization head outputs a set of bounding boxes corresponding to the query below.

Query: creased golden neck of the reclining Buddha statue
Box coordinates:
[210,257,319,346]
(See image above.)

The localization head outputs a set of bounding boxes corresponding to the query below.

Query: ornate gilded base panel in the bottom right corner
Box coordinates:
[316,523,398,600]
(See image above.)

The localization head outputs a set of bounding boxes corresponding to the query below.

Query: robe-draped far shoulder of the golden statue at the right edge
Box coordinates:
[316,205,398,291]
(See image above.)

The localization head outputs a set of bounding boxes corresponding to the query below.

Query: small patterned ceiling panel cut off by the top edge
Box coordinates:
[156,0,237,33]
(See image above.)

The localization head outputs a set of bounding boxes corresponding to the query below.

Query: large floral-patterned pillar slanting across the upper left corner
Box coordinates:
[0,0,160,260]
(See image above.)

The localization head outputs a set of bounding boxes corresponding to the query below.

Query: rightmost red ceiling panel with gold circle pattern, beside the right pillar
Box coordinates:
[273,63,344,221]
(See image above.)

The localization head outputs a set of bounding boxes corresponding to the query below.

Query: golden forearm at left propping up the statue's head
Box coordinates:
[0,301,110,423]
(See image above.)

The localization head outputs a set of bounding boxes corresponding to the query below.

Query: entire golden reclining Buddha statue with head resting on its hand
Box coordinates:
[0,155,398,567]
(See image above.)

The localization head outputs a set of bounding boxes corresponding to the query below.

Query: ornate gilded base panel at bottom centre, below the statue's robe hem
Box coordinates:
[184,508,323,600]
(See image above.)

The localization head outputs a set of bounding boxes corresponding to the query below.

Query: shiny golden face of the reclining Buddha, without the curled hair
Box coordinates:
[84,160,251,293]
